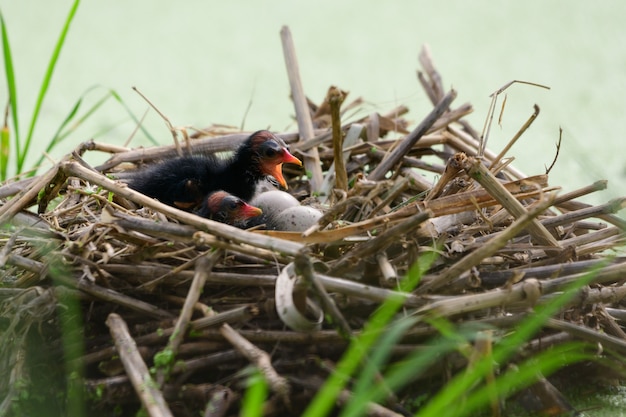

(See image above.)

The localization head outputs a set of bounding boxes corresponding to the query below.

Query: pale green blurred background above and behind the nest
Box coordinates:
[0,0,626,202]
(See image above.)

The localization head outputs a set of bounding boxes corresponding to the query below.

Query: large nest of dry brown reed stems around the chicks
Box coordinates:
[0,44,626,416]
